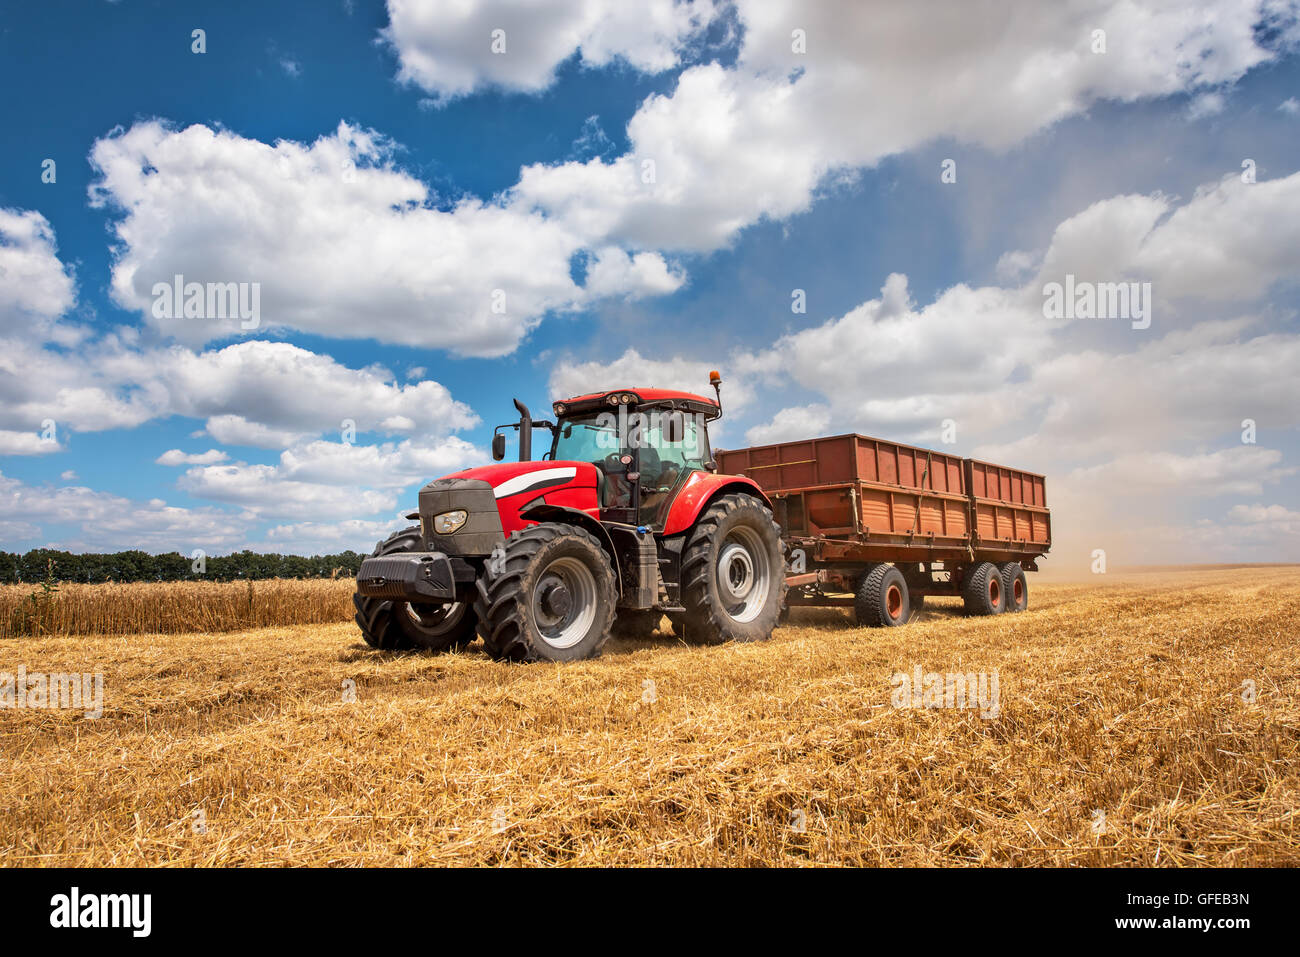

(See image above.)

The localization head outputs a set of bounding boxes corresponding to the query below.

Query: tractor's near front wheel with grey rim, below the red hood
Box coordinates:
[475,524,618,662]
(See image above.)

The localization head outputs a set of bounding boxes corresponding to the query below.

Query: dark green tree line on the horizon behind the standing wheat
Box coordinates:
[0,549,365,585]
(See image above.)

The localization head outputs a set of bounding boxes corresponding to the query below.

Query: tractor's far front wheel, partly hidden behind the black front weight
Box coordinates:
[352,525,478,651]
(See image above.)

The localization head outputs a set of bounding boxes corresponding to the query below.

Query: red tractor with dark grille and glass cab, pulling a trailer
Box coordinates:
[354,372,785,661]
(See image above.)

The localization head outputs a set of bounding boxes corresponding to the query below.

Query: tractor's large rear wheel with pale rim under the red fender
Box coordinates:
[673,493,785,645]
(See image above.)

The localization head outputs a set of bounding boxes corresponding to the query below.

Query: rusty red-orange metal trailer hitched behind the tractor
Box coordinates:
[715,434,1052,627]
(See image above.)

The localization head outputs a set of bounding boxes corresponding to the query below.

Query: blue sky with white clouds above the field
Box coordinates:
[0,0,1300,567]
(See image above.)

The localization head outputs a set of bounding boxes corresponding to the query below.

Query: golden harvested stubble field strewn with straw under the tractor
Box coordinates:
[0,567,1300,866]
